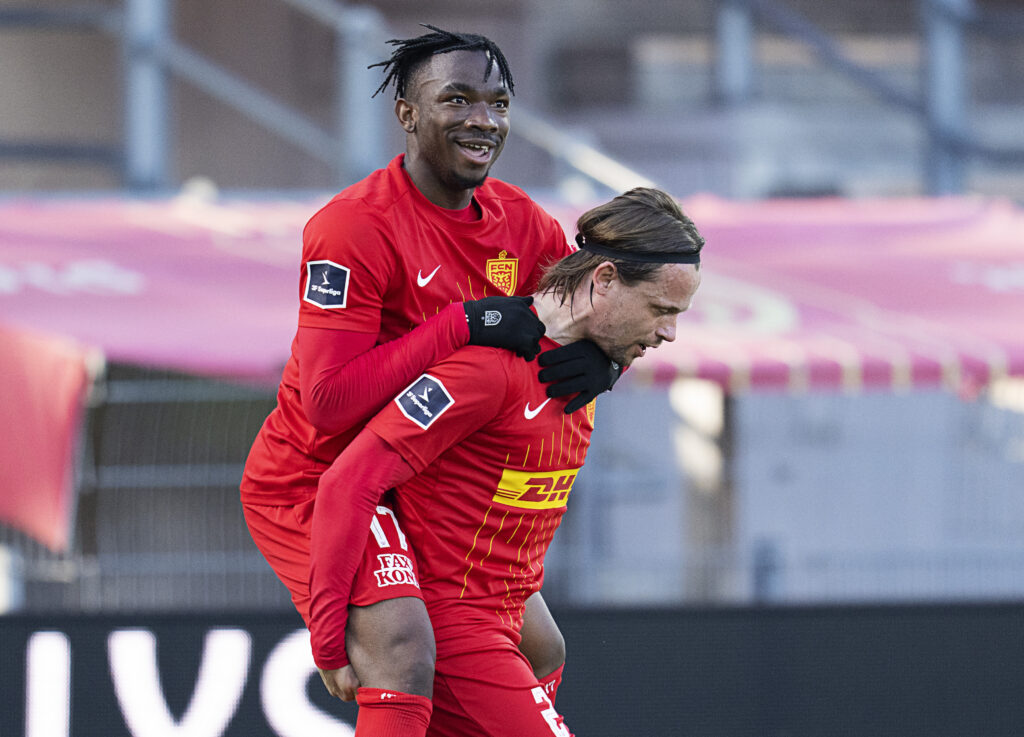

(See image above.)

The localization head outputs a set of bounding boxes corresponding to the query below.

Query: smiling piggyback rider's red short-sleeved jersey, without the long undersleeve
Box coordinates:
[242,155,571,504]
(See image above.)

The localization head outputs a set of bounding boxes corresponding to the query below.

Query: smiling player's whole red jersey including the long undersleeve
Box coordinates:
[242,156,571,505]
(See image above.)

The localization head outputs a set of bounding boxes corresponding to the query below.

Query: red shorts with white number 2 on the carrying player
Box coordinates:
[427,650,572,737]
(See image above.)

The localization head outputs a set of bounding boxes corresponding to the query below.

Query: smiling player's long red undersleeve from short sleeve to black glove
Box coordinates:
[297,303,469,435]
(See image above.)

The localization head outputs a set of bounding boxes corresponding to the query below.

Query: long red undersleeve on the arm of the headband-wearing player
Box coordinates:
[309,432,414,670]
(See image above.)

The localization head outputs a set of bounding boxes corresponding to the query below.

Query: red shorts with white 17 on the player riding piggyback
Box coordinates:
[242,497,423,624]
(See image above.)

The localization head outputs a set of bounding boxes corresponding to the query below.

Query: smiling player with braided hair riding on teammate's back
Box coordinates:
[241,27,617,737]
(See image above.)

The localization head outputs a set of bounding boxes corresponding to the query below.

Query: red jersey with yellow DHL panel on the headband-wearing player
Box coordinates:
[310,338,594,662]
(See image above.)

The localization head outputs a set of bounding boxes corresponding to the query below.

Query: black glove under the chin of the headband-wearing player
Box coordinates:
[537,340,623,415]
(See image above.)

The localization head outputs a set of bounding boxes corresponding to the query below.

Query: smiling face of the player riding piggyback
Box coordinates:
[395,51,509,208]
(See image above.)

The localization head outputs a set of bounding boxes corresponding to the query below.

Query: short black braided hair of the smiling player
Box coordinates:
[367,24,515,99]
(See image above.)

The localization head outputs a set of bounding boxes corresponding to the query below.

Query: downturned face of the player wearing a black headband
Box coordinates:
[588,264,700,365]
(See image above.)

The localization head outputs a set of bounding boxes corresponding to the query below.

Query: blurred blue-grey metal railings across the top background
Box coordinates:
[0,0,1024,194]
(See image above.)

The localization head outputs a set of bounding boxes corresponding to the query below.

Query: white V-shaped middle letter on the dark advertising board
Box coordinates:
[108,630,252,737]
